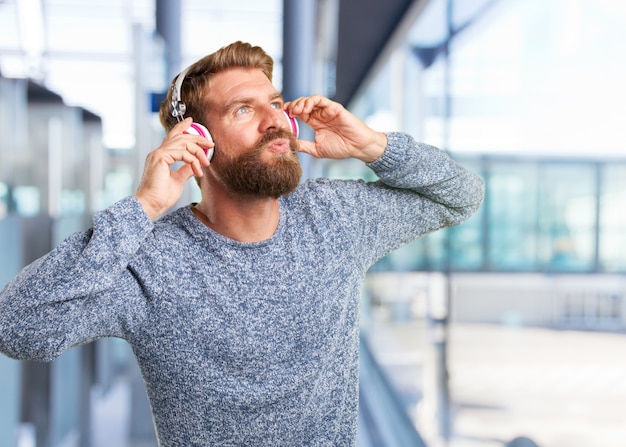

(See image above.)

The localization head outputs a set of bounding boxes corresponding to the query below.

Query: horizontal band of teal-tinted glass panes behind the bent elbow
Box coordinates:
[352,155,626,273]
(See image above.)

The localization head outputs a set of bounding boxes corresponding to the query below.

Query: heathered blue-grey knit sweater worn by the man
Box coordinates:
[0,133,483,447]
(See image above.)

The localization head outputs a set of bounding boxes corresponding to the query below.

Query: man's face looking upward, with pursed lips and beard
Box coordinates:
[206,68,302,198]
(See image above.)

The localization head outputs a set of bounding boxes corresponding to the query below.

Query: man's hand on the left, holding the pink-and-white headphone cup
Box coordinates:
[135,118,215,220]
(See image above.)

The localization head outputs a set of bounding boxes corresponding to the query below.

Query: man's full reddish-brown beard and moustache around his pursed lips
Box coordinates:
[212,130,302,199]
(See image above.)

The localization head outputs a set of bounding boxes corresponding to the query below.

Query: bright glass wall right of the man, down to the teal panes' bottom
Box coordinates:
[344,0,626,273]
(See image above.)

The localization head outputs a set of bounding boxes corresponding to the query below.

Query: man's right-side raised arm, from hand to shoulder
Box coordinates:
[286,95,485,265]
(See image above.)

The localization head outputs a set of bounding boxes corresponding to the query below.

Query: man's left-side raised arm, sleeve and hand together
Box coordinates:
[0,118,214,360]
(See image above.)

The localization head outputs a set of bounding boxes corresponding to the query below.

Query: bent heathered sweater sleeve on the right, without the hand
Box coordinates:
[357,132,485,263]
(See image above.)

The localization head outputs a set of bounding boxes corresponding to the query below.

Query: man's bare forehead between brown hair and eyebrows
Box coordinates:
[207,68,278,107]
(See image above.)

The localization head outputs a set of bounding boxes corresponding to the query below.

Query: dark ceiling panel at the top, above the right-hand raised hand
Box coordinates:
[334,0,418,104]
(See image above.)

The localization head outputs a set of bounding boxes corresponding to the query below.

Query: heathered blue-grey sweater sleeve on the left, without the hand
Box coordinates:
[0,197,153,361]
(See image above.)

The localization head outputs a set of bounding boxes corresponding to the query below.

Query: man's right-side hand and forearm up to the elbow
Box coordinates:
[285,95,484,219]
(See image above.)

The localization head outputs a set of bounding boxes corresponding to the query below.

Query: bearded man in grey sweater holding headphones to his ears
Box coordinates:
[0,42,483,446]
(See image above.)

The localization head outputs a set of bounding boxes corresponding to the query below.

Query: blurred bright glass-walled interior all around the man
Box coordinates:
[0,0,626,447]
